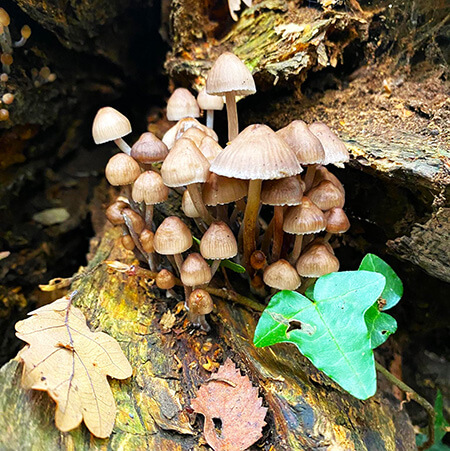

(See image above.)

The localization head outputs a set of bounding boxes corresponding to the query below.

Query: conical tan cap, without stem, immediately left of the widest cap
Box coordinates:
[161,138,209,187]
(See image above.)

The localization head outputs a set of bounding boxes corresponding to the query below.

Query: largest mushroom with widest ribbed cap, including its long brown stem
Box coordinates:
[210,124,302,273]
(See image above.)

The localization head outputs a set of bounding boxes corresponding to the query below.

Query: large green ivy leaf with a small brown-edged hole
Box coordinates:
[254,271,385,399]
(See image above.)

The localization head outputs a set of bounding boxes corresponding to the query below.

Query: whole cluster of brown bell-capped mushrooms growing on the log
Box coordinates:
[93,52,350,330]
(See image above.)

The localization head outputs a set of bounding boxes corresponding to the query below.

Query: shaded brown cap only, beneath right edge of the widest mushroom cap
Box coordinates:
[261,176,303,206]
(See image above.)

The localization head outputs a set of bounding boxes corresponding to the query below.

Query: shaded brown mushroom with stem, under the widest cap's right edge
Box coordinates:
[261,176,303,261]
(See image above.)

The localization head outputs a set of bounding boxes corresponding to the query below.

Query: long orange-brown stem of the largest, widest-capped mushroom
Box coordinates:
[243,179,262,275]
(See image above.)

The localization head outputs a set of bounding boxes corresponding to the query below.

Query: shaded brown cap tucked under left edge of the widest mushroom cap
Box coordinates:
[203,172,248,206]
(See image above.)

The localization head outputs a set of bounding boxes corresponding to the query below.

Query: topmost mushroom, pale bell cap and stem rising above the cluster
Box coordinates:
[206,52,256,141]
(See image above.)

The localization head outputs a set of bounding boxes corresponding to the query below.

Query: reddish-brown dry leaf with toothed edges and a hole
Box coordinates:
[191,359,267,451]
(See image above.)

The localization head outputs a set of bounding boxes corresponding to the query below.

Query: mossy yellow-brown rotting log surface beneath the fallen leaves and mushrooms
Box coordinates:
[0,228,415,451]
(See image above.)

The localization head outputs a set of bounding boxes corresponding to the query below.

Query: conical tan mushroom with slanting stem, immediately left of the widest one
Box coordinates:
[161,138,213,224]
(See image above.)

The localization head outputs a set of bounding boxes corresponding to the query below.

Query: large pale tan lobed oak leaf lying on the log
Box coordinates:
[16,296,132,438]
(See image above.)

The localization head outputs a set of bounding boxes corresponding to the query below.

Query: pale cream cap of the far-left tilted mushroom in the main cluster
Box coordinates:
[92,106,131,144]
